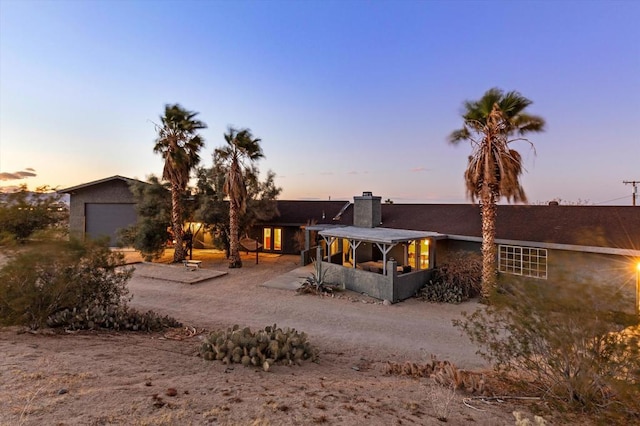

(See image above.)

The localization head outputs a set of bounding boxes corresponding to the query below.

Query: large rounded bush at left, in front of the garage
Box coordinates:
[0,240,133,329]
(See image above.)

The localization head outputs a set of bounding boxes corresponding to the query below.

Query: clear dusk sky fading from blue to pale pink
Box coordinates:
[0,0,640,205]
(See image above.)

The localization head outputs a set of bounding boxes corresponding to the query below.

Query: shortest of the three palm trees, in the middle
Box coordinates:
[214,127,264,268]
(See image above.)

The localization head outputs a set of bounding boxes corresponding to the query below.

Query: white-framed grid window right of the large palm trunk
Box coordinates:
[498,245,547,280]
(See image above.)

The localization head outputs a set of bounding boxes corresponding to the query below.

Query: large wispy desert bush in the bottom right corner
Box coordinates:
[454,280,640,421]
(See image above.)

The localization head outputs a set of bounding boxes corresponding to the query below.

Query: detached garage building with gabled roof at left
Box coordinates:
[58,175,145,246]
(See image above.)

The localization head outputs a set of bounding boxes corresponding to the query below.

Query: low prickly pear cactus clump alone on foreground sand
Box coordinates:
[200,324,317,371]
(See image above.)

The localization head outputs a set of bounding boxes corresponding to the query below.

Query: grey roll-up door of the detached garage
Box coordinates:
[84,203,136,246]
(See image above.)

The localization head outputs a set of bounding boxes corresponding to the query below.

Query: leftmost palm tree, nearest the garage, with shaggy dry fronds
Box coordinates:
[153,104,207,262]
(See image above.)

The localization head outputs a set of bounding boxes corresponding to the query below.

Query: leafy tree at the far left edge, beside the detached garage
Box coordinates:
[0,185,69,245]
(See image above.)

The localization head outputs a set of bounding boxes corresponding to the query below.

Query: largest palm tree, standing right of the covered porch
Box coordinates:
[449,88,545,300]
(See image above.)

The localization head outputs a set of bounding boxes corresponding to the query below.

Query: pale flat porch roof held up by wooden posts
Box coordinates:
[320,226,446,244]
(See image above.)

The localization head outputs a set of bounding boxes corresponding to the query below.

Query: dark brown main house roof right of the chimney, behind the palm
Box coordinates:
[382,204,640,250]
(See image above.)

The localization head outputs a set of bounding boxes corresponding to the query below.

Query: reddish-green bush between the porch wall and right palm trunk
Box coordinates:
[418,251,482,303]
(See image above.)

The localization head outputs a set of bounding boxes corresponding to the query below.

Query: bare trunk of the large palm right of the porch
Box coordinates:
[481,185,498,301]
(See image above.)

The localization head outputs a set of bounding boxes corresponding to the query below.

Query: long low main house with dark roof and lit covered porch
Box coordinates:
[253,193,640,301]
